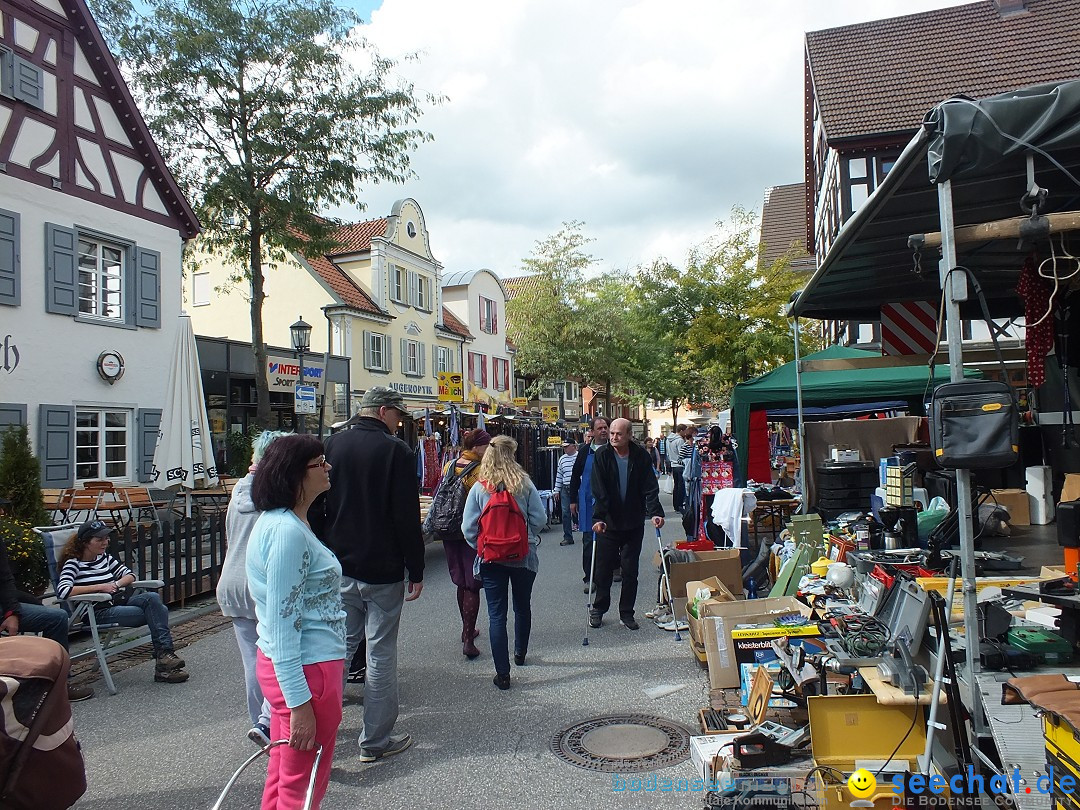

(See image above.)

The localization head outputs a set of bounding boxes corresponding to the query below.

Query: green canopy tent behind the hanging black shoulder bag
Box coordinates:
[731,346,982,481]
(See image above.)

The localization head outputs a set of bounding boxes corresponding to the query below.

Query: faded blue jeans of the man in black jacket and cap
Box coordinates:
[341,577,405,751]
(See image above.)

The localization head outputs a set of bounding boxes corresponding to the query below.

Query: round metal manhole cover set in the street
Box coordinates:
[551,714,690,773]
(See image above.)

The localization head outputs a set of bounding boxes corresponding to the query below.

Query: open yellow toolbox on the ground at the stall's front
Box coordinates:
[807,694,927,810]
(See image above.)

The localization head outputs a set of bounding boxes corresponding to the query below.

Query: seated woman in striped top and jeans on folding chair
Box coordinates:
[56,521,188,684]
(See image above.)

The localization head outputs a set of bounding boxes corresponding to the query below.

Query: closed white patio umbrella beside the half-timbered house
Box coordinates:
[151,312,218,516]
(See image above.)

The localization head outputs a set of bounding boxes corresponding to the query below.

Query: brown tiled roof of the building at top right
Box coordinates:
[806,0,1080,143]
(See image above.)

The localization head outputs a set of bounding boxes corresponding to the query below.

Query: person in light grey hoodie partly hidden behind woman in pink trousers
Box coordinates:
[217,430,288,745]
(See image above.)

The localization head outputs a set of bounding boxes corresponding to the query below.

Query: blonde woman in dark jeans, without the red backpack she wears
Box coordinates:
[461,436,548,689]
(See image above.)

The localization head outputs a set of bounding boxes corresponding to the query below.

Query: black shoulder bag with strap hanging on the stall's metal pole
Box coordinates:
[930,267,1020,470]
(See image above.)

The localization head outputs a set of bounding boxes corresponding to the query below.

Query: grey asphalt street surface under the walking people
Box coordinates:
[72,516,707,810]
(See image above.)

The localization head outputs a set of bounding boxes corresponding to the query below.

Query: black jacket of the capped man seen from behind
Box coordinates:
[310,417,423,584]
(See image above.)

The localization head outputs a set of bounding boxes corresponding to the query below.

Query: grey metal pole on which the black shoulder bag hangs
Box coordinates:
[937,180,986,750]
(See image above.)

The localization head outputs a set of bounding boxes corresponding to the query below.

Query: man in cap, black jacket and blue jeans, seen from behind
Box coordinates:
[309,386,423,762]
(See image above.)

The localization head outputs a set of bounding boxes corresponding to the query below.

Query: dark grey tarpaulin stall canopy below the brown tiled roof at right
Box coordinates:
[791,81,1080,321]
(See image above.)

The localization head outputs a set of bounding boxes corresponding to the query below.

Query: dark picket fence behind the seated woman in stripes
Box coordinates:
[112,513,227,606]
